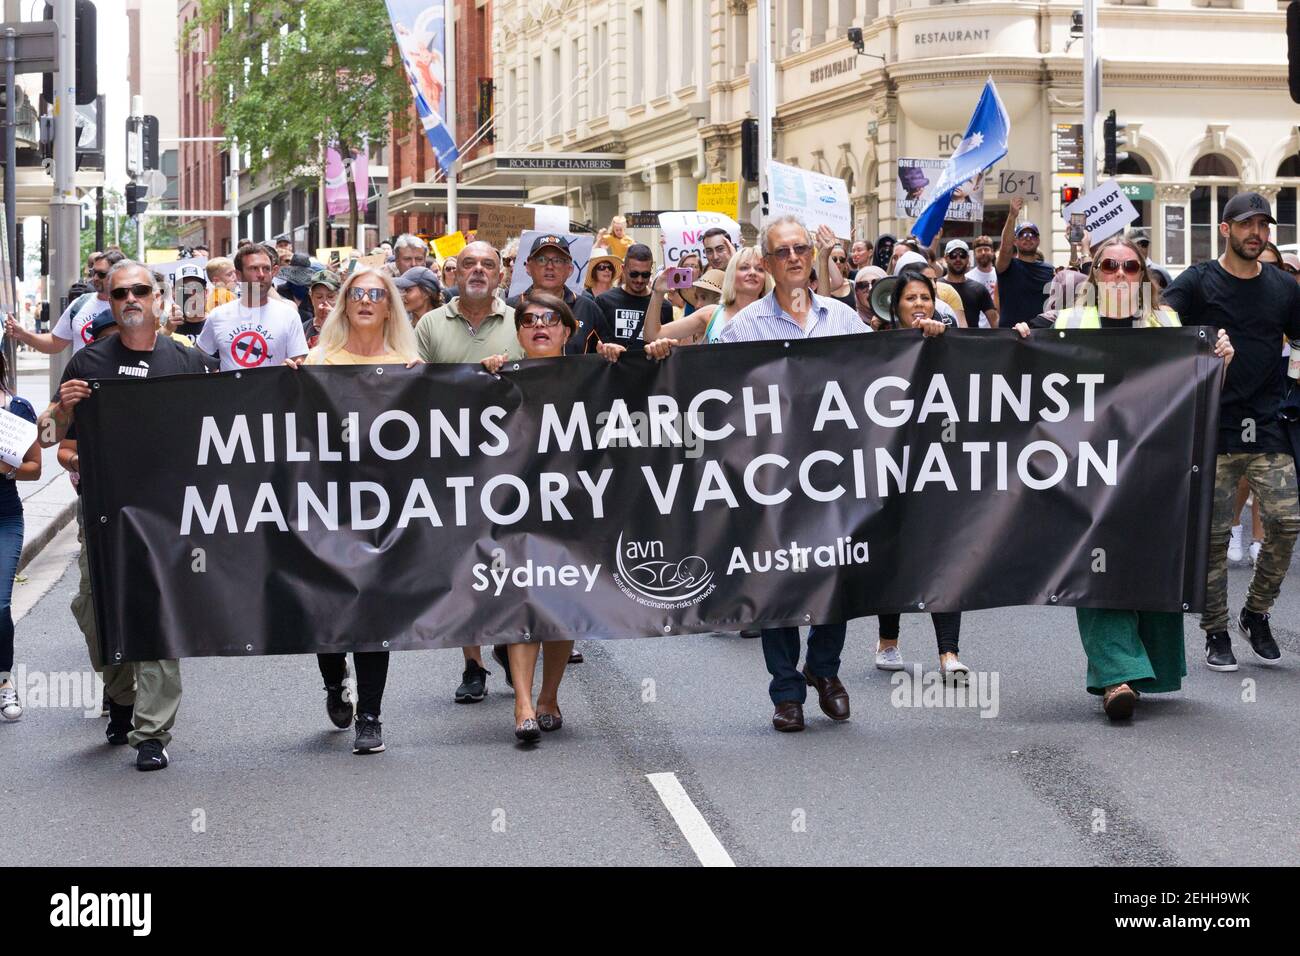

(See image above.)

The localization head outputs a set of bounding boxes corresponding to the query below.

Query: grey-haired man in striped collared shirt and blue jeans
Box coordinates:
[722,216,870,732]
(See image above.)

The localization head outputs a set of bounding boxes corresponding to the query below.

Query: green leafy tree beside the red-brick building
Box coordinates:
[181,0,411,242]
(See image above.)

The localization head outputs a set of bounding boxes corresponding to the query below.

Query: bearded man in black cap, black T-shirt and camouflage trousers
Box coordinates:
[1165,193,1300,671]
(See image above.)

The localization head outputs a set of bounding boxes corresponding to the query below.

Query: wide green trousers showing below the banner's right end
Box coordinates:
[1075,607,1187,695]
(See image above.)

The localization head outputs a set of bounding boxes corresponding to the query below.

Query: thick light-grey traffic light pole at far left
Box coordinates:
[49,0,81,394]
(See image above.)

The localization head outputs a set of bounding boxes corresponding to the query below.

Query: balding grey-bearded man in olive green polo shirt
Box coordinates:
[415,242,524,704]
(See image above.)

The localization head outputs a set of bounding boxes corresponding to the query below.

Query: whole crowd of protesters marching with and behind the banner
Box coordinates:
[0,193,1300,770]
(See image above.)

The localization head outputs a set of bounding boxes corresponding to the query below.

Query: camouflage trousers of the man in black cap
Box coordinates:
[1201,451,1300,633]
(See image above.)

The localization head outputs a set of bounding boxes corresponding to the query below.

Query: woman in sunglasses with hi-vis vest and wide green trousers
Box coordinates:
[1015,235,1232,721]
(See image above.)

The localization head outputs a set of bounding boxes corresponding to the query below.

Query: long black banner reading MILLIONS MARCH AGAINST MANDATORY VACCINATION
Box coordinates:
[77,329,1221,661]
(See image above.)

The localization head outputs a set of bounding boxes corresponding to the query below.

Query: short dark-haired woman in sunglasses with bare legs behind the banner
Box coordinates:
[482,289,676,744]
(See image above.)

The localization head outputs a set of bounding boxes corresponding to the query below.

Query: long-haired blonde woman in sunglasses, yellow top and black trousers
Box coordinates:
[285,267,420,754]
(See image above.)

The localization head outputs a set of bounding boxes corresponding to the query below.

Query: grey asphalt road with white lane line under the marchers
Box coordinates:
[0,532,1300,866]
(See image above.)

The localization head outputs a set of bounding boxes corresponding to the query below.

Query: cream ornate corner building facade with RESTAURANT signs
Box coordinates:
[491,0,1300,269]
